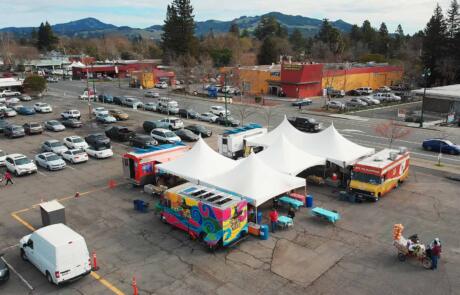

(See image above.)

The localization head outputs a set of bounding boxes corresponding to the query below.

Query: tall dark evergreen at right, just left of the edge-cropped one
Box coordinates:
[422,4,447,85]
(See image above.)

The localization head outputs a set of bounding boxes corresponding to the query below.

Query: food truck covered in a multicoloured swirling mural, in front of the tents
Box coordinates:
[158,182,248,250]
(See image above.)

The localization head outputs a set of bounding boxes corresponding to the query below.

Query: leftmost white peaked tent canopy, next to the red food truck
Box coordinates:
[157,138,237,183]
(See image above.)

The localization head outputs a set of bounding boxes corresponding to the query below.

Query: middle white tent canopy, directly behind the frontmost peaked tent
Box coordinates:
[257,135,326,176]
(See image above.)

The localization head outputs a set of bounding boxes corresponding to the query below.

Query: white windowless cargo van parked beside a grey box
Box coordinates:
[19,223,91,285]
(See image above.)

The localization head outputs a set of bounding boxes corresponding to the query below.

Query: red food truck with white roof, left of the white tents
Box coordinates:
[122,143,190,185]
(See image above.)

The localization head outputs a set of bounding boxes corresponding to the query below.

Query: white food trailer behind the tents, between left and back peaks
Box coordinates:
[217,123,267,159]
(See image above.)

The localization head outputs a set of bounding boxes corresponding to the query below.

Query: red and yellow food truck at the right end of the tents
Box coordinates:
[349,148,410,201]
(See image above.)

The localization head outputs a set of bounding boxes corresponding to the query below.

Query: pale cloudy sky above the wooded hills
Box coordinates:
[0,0,450,33]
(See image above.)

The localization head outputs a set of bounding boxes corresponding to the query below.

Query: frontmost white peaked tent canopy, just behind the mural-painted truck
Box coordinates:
[203,154,305,207]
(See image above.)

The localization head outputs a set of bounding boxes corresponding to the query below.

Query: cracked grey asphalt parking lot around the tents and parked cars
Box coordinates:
[0,81,460,294]
